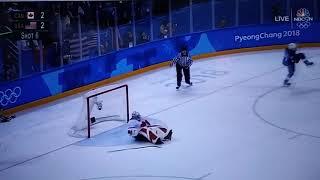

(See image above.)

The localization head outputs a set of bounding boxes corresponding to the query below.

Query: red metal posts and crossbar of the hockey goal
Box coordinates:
[86,84,129,138]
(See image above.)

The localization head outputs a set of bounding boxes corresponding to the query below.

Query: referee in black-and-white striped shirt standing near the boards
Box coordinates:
[170,47,193,89]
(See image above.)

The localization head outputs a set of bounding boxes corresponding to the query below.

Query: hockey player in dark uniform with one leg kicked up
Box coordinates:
[282,43,313,86]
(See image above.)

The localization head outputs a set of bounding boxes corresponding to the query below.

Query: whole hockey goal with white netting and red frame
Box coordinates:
[69,85,129,138]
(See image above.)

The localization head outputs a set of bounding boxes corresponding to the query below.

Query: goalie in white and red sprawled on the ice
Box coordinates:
[128,111,172,144]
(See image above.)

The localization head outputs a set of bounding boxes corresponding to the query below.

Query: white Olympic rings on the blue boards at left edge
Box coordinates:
[0,86,21,107]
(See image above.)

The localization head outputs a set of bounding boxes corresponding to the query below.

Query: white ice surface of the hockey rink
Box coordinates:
[0,48,320,180]
